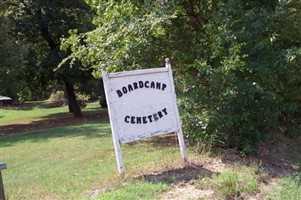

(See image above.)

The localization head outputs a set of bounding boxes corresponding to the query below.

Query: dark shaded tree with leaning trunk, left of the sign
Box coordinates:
[5,0,93,116]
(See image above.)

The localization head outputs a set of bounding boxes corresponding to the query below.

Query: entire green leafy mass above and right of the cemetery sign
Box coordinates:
[61,0,301,154]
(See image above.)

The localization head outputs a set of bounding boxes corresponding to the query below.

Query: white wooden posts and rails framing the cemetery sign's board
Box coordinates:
[101,58,186,174]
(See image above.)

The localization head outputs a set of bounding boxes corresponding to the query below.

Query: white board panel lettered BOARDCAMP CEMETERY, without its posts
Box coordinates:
[106,65,179,141]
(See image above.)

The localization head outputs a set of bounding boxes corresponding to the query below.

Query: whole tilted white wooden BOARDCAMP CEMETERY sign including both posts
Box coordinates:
[102,59,186,173]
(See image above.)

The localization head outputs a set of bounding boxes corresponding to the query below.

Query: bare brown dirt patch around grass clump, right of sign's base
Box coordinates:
[145,145,300,200]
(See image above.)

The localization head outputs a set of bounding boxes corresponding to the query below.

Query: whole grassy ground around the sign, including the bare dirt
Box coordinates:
[0,102,301,200]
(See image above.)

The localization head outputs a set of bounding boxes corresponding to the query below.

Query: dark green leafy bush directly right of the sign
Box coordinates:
[181,1,301,154]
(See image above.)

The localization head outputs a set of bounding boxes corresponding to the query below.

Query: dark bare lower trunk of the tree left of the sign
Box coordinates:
[65,81,82,117]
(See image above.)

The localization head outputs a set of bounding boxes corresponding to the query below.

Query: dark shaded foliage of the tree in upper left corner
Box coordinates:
[1,0,97,108]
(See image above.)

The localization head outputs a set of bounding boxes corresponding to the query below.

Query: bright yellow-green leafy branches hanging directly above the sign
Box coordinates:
[62,1,173,72]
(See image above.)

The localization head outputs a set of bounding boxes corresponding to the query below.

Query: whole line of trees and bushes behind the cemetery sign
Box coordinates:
[0,0,301,153]
